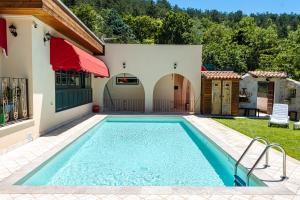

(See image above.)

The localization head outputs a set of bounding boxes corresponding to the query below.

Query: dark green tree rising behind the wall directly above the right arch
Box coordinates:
[156,11,193,44]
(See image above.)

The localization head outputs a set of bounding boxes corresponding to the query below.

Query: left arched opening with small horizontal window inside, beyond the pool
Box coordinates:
[103,73,145,112]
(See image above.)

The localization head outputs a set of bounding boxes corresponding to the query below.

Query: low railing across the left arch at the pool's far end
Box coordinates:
[103,98,145,112]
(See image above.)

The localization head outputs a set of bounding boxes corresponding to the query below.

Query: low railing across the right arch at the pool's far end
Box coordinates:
[153,99,195,113]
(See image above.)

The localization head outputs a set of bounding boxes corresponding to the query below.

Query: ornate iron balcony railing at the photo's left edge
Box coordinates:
[0,77,29,126]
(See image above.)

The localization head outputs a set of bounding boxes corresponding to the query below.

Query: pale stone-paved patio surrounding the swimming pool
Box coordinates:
[0,115,300,200]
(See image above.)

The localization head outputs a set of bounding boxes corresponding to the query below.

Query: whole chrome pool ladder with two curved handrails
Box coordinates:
[234,137,287,186]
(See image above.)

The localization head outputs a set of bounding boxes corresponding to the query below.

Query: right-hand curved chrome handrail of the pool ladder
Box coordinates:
[247,143,287,185]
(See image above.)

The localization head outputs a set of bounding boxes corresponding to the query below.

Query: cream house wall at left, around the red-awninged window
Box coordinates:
[2,15,92,136]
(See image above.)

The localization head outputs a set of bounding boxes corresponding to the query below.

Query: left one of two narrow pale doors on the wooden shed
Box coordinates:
[211,81,222,115]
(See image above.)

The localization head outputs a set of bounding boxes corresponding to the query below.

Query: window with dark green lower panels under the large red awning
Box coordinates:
[55,71,92,112]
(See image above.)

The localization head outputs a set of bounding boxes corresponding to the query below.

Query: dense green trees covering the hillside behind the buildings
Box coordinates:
[64,0,300,80]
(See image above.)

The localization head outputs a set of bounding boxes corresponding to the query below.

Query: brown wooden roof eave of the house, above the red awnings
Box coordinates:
[0,0,105,55]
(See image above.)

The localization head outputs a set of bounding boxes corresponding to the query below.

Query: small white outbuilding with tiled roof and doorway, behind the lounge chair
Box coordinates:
[240,71,300,118]
